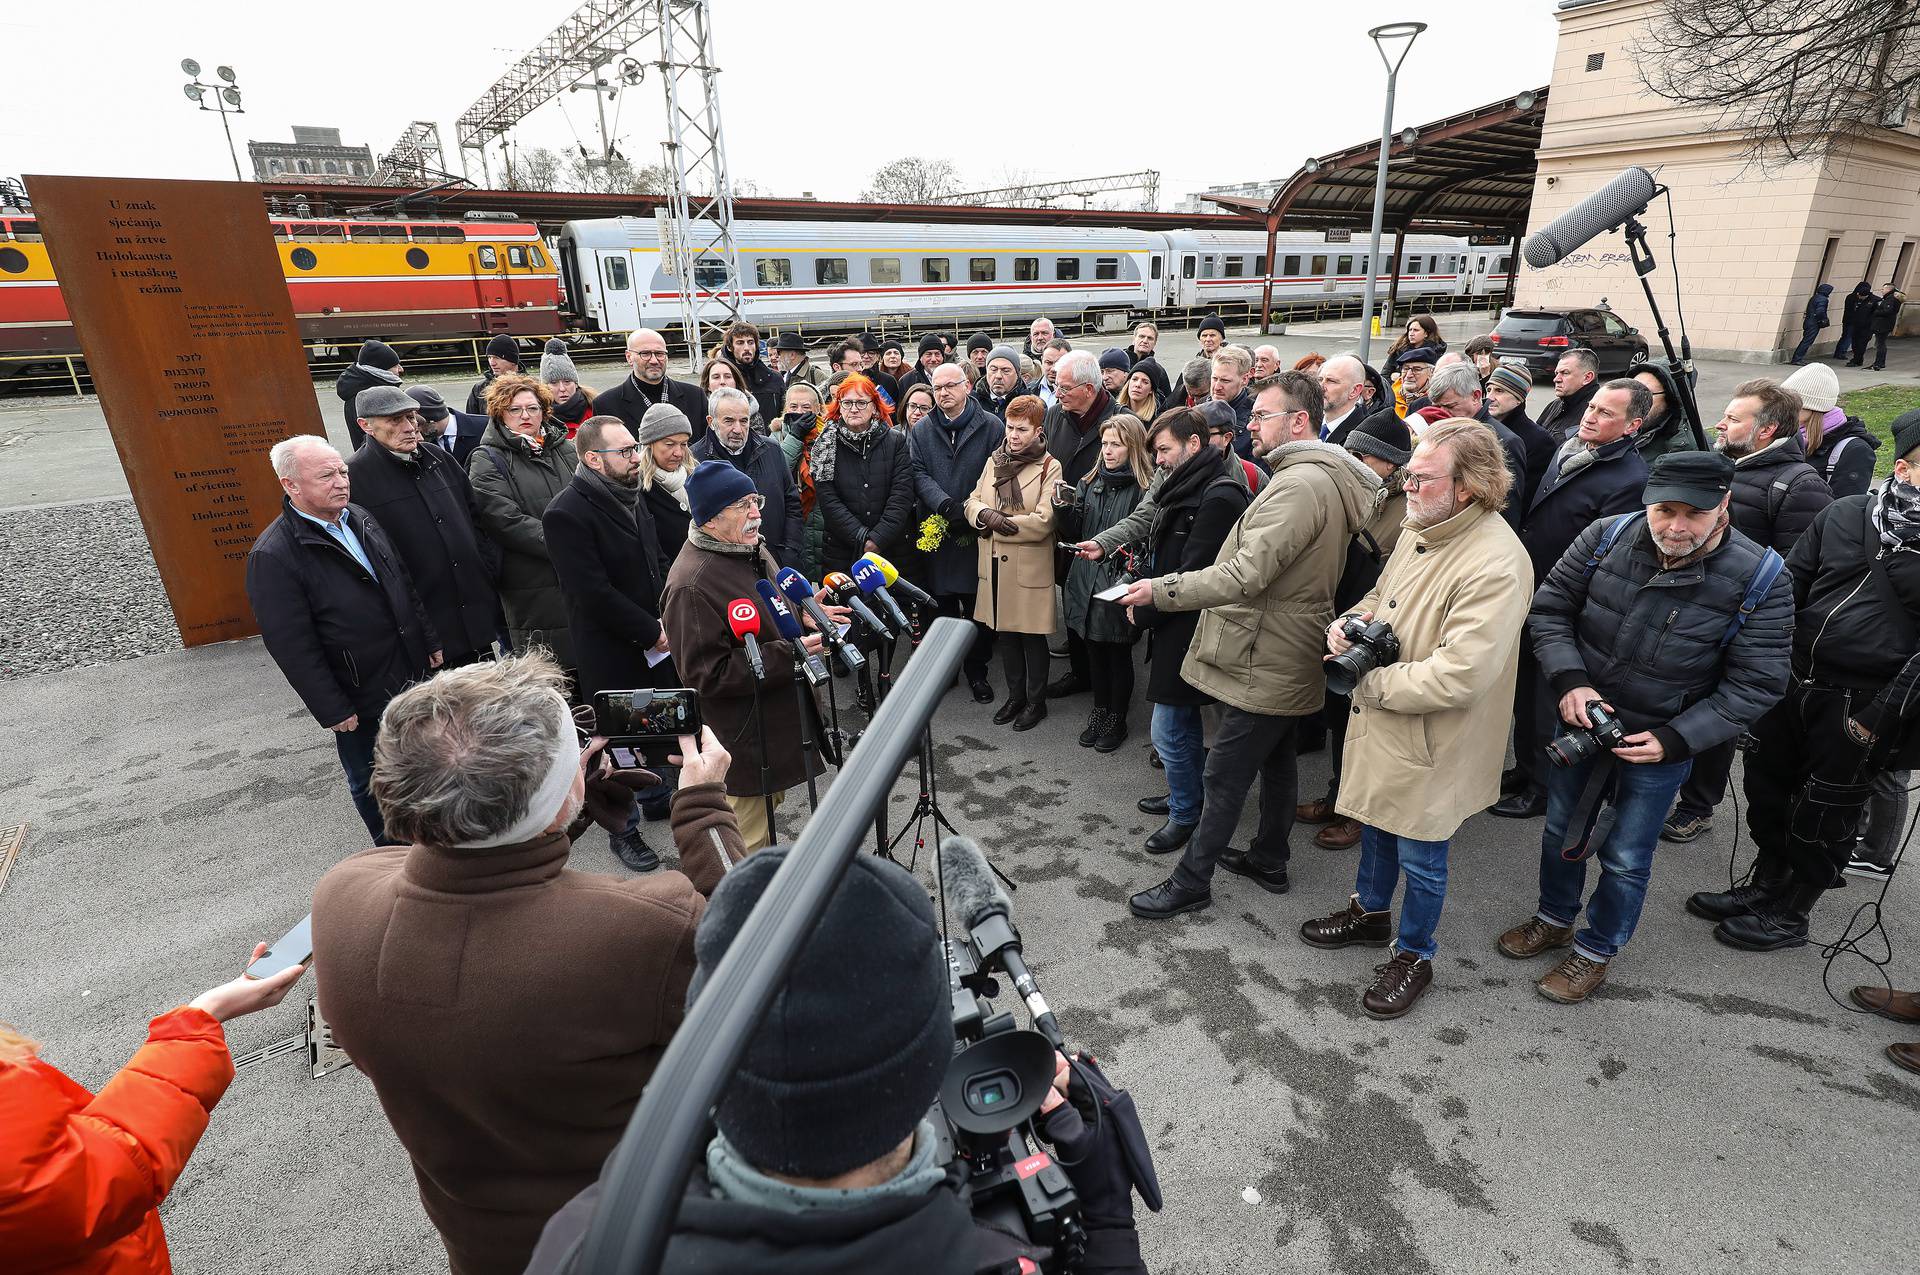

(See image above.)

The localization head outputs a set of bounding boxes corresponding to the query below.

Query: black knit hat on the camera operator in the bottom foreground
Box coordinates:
[687,844,954,1177]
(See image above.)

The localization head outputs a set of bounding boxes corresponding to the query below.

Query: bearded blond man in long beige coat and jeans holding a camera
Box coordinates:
[1300,422,1528,1018]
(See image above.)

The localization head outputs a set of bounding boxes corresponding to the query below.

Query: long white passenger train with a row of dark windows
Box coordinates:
[557,217,1509,332]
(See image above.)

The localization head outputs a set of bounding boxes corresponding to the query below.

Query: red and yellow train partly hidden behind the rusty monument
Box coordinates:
[0,211,561,355]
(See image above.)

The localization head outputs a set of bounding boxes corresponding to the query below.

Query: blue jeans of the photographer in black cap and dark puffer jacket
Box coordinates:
[1536,757,1693,960]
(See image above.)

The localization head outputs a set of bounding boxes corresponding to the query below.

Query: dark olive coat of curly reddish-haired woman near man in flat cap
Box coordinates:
[467,421,580,668]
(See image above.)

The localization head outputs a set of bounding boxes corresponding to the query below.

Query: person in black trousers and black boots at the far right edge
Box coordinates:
[1686,411,1920,952]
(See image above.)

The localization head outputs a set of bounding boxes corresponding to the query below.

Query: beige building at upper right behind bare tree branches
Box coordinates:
[1515,0,1920,363]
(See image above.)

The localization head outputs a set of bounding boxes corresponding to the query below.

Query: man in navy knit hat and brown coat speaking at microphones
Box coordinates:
[660,465,837,851]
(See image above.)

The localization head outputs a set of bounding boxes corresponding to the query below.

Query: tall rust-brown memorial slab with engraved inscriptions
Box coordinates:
[27,177,326,647]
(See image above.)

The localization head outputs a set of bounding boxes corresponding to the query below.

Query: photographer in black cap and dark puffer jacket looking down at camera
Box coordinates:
[1498,451,1793,1004]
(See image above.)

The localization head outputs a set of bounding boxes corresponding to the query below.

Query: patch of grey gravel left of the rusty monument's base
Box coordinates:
[0,499,180,682]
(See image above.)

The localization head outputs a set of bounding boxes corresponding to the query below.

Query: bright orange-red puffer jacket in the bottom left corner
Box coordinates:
[0,1006,234,1275]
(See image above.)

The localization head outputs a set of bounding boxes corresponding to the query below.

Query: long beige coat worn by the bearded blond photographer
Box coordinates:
[1334,505,1534,841]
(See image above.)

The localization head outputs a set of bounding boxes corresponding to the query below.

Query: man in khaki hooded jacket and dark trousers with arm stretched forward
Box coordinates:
[1119,371,1380,920]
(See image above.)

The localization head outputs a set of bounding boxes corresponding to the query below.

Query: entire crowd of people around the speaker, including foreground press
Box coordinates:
[0,296,1920,1275]
